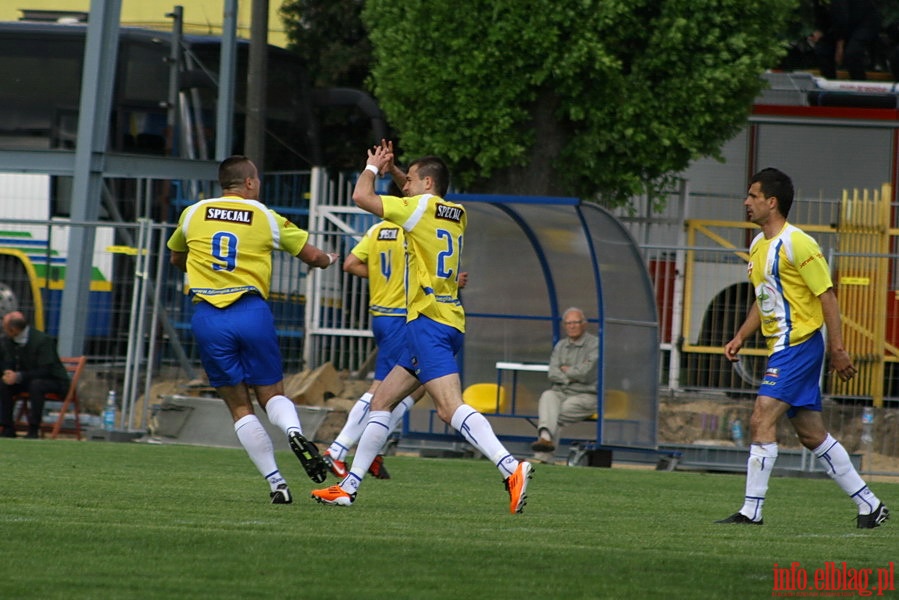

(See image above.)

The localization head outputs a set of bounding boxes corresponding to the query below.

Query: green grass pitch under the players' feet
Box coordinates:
[0,439,899,600]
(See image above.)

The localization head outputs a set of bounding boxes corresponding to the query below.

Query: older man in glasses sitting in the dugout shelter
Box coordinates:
[531,307,599,462]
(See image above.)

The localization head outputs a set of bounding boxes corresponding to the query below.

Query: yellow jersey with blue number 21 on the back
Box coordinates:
[381,194,468,333]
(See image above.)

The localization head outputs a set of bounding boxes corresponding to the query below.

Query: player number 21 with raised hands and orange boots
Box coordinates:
[312,144,533,513]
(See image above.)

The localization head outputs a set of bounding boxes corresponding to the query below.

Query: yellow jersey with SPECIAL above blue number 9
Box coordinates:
[167,196,309,308]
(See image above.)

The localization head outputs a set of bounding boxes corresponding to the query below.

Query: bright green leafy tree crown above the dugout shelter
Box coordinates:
[362,0,796,204]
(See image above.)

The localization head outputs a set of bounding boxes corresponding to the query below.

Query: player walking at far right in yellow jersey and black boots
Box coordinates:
[717,168,889,529]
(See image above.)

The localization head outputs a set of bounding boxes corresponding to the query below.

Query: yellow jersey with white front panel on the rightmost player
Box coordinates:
[747,223,833,354]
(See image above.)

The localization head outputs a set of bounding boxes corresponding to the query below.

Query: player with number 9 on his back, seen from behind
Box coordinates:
[168,156,337,504]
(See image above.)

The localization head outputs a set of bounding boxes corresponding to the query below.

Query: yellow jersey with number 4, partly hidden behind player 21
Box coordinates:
[350,221,406,317]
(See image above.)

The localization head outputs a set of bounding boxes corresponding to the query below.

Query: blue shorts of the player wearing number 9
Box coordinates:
[190,294,284,387]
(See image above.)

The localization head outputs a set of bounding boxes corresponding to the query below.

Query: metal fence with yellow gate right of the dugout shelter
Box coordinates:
[623,186,899,473]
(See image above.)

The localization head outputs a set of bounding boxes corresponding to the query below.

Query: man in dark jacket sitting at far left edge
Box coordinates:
[0,311,69,438]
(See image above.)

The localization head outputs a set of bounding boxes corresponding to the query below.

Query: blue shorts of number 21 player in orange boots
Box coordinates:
[398,315,465,383]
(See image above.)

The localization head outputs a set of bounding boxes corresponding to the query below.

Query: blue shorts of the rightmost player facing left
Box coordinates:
[759,332,824,418]
